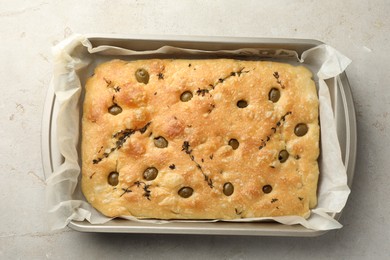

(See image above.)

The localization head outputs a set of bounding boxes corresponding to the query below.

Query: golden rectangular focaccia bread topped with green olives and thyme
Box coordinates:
[82,59,320,219]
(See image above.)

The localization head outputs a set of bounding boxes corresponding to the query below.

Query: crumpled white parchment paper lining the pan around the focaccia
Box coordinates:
[46,35,351,230]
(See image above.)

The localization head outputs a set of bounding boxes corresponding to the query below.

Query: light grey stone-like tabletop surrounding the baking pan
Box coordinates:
[0,0,390,259]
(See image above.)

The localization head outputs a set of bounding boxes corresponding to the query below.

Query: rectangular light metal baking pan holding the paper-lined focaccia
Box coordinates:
[41,35,357,236]
